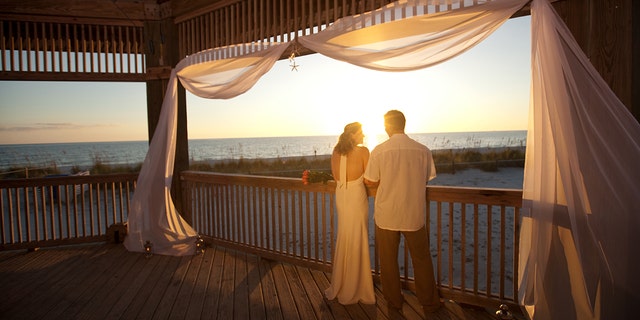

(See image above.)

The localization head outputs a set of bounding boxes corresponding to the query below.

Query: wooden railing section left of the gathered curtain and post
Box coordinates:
[0,174,137,250]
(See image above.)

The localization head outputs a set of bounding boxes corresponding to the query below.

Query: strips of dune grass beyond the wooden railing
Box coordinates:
[0,148,525,179]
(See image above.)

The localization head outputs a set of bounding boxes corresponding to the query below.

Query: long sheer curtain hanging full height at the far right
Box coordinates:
[519,0,640,319]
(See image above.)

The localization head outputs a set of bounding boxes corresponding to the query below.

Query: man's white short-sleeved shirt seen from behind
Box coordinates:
[364,134,436,231]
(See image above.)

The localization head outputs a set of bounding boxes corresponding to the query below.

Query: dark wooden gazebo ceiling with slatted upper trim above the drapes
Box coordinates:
[0,0,528,81]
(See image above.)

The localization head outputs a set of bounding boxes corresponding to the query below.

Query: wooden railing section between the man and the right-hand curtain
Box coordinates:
[428,186,522,307]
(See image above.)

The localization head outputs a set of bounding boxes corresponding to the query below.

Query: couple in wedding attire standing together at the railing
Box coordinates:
[325,110,442,313]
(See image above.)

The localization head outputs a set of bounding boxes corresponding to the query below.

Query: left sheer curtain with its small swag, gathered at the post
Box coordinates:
[124,43,288,256]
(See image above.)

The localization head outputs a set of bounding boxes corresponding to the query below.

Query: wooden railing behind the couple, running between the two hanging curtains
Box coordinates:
[181,172,522,307]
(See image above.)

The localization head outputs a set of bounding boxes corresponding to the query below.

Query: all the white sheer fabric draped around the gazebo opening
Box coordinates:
[125,0,640,319]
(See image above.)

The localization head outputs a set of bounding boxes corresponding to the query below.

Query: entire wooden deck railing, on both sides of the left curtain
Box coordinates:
[0,171,522,307]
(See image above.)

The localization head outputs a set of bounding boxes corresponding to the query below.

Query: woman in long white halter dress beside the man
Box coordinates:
[325,122,376,305]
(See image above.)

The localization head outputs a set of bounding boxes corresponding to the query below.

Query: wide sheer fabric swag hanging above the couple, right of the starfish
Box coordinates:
[298,0,527,71]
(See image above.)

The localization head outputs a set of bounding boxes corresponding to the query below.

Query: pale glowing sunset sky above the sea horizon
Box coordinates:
[0,17,531,144]
